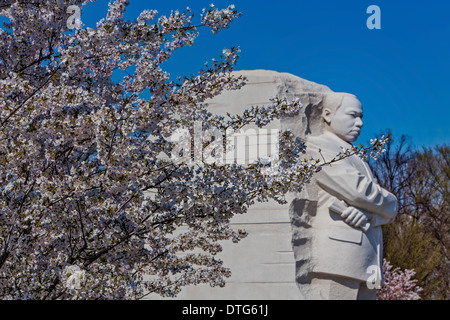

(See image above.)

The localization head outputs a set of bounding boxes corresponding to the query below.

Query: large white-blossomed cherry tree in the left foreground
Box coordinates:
[0,0,382,299]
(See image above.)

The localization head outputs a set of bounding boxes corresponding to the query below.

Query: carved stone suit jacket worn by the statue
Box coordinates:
[300,132,397,281]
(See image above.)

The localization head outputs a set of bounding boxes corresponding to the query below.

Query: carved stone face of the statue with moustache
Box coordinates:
[323,95,363,142]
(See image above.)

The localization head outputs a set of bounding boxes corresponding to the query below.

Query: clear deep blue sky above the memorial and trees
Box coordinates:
[14,0,450,146]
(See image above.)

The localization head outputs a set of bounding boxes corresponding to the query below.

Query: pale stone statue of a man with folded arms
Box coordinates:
[290,92,397,300]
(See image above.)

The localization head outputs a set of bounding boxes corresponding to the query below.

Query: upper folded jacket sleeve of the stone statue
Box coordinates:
[315,154,397,225]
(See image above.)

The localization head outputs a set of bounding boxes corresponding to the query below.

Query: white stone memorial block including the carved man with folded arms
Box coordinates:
[150,70,396,300]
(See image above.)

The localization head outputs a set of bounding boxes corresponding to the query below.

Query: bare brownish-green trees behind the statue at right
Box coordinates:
[370,132,450,299]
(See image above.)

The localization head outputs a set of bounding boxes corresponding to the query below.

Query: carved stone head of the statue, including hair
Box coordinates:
[322,92,363,142]
